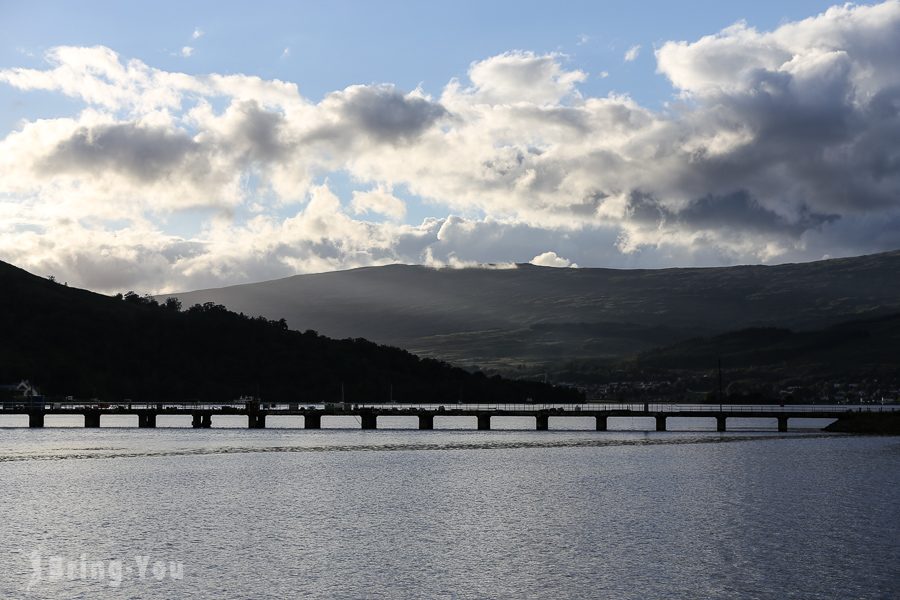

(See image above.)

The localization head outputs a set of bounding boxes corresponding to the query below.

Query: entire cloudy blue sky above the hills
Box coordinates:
[0,0,900,293]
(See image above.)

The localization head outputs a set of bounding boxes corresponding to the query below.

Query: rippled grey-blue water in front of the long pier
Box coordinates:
[0,421,900,599]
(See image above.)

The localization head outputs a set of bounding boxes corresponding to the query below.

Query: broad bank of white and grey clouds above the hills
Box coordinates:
[0,1,900,291]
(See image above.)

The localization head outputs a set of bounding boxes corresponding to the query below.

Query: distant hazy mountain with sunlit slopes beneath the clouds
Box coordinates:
[162,252,900,373]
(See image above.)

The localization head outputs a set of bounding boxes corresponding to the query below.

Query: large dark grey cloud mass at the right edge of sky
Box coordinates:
[697,82,900,216]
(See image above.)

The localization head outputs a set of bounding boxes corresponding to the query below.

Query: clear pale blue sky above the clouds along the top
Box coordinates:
[0,0,834,116]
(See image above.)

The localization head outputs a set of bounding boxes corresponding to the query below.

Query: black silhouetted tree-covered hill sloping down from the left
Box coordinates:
[0,263,581,403]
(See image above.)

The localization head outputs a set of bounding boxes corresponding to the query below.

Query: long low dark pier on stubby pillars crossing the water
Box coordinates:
[0,401,900,431]
